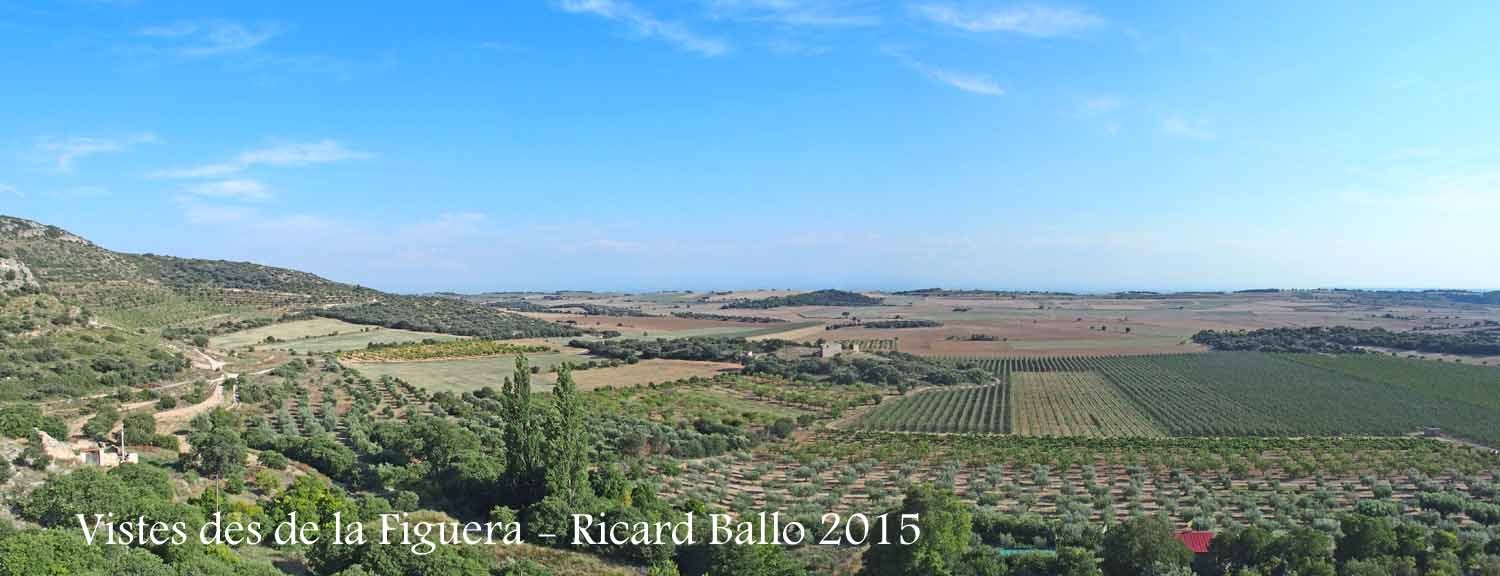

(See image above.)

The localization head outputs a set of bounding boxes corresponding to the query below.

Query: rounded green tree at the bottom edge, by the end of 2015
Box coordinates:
[861,485,974,576]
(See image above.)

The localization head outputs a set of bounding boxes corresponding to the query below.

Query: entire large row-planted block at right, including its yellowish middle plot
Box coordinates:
[861,353,1500,446]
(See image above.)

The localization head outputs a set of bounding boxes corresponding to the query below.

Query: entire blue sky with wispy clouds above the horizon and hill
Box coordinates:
[0,0,1500,291]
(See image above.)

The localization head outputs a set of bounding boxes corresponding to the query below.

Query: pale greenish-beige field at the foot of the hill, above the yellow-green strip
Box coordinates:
[209,318,459,354]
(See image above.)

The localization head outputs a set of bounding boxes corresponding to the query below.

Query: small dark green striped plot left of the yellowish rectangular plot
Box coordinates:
[860,383,1008,434]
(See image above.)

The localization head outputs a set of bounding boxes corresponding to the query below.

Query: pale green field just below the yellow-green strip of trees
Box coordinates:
[347,353,587,393]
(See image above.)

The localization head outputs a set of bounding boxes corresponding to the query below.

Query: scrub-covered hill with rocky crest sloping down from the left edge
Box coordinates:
[0,216,579,338]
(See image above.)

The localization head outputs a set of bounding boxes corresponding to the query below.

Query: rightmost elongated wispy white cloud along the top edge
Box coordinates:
[912,3,1104,38]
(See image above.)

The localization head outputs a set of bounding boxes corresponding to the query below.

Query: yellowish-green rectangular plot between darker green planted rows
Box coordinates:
[1011,372,1164,438]
